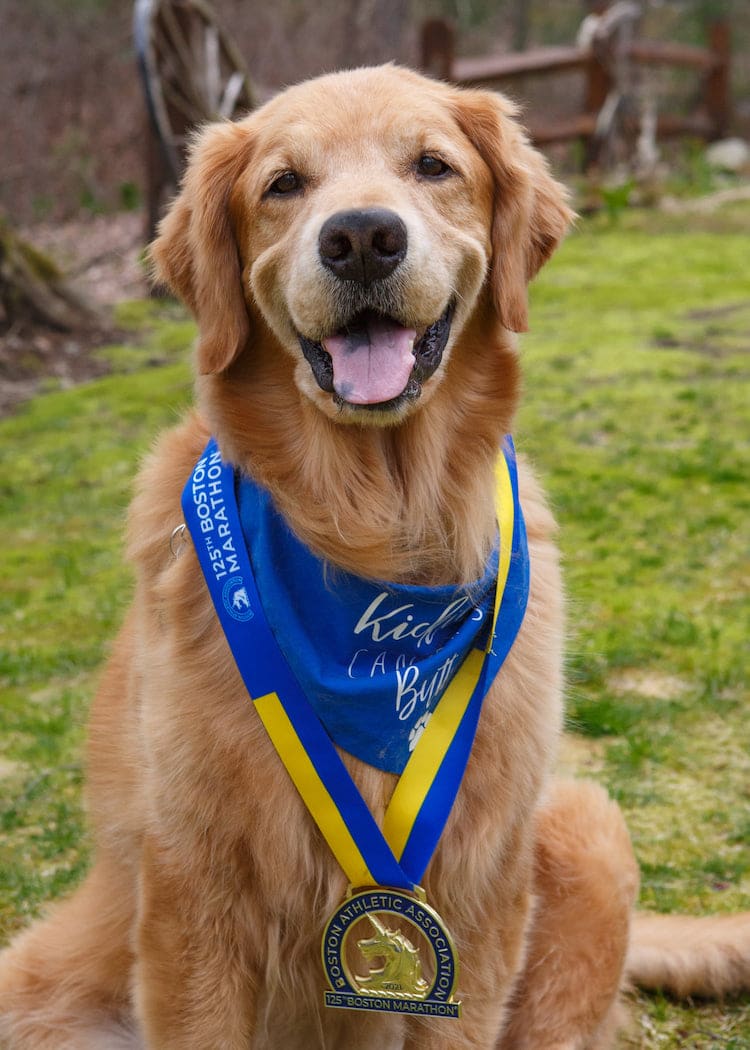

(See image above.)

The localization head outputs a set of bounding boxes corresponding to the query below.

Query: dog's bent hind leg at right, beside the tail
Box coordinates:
[499,781,639,1050]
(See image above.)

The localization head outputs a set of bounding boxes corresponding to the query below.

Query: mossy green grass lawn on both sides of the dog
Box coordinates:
[0,207,750,1050]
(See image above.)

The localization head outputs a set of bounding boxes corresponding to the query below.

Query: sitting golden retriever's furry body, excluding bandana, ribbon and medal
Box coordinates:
[0,66,750,1050]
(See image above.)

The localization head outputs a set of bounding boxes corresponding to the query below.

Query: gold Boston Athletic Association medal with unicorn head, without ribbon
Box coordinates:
[322,886,461,1017]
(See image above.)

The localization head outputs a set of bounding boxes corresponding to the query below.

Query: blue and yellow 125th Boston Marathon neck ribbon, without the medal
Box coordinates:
[183,439,528,890]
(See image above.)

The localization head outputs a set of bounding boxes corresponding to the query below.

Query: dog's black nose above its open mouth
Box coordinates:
[318,208,407,285]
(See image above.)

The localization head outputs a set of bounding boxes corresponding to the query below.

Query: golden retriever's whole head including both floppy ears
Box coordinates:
[152,66,570,423]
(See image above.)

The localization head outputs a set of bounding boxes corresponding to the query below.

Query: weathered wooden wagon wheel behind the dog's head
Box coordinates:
[133,0,256,182]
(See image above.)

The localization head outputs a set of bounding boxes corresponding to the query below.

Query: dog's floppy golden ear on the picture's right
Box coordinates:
[454,91,575,332]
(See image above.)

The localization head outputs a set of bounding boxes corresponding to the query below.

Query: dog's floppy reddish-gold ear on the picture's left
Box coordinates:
[150,122,252,374]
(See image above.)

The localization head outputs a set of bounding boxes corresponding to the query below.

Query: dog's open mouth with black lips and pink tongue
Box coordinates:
[298,303,454,410]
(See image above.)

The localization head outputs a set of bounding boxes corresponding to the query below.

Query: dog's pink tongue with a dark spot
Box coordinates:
[322,316,417,404]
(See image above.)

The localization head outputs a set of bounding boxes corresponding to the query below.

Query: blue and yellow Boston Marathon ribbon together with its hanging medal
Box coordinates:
[182,439,528,1016]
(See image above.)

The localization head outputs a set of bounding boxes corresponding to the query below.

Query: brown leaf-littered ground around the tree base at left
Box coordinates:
[0,212,148,417]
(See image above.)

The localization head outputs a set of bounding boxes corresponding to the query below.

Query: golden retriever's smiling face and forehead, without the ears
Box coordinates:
[232,64,492,415]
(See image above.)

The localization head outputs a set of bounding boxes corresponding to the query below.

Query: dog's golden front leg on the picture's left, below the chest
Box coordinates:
[134,841,254,1050]
